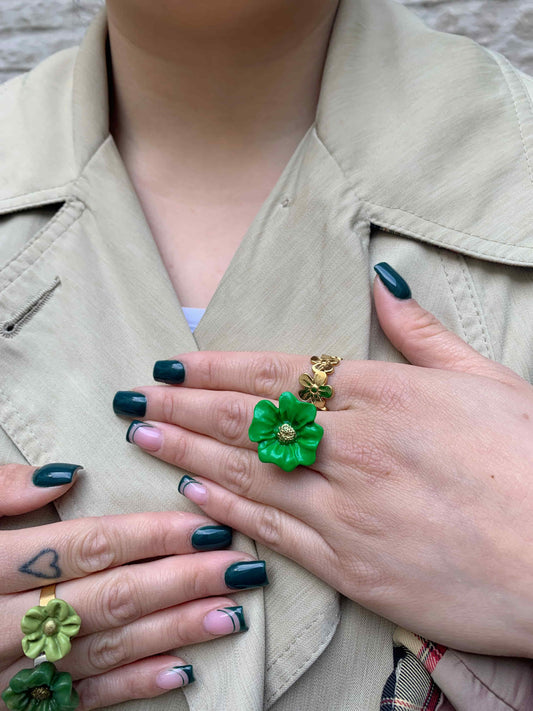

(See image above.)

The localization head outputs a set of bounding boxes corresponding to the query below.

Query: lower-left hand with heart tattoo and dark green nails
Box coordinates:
[0,464,268,710]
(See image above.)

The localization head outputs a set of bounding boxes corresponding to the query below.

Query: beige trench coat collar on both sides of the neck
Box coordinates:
[0,0,533,265]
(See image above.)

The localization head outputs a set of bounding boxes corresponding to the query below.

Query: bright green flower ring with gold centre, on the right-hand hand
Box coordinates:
[248,392,324,472]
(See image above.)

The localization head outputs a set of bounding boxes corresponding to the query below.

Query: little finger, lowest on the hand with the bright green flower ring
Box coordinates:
[176,477,336,589]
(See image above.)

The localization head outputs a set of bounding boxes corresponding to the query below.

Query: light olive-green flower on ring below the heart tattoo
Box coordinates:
[20,599,81,662]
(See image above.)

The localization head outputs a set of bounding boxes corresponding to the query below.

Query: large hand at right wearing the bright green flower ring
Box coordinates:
[118,278,533,657]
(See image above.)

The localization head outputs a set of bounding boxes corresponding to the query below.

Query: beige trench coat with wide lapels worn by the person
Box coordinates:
[0,0,533,711]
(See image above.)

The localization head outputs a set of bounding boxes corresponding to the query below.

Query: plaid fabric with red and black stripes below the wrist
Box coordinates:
[380,627,446,711]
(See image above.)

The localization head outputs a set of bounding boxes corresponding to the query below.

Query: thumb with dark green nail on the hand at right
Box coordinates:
[374,262,519,382]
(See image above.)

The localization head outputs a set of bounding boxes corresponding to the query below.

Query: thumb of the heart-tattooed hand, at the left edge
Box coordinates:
[0,463,82,516]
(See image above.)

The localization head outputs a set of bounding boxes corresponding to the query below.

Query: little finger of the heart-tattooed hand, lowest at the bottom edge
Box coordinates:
[76,655,195,711]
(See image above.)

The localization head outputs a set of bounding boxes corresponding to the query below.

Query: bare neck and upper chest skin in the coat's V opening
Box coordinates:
[107,0,338,307]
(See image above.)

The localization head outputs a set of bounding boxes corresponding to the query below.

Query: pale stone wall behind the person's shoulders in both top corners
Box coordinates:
[0,0,533,83]
